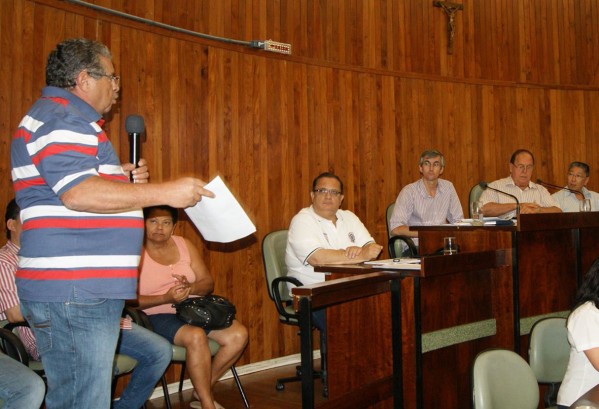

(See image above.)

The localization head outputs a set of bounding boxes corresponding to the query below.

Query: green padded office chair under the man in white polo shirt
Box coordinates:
[262,230,329,398]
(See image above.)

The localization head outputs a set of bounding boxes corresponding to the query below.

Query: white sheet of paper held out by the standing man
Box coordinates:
[185,176,256,243]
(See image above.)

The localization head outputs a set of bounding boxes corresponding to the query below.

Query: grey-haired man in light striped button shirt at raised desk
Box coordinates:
[389,150,464,245]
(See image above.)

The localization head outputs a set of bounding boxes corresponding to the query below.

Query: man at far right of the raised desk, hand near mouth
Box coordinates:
[553,162,599,212]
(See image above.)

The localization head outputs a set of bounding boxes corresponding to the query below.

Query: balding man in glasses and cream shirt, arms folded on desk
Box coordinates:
[480,149,561,219]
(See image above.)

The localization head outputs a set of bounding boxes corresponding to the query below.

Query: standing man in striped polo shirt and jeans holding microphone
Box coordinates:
[11,38,214,409]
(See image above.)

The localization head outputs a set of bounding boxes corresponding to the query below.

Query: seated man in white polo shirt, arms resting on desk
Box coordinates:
[285,172,383,329]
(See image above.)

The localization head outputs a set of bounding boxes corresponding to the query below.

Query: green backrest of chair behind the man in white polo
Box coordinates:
[262,230,291,301]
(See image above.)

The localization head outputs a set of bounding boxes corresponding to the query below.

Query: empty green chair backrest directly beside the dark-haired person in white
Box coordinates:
[528,317,570,383]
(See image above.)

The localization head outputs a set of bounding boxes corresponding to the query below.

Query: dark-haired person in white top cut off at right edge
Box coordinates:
[557,259,599,409]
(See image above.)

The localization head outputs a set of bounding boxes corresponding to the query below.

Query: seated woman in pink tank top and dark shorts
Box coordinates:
[139,206,248,409]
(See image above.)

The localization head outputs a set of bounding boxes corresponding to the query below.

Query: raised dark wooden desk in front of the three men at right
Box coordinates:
[411,212,599,350]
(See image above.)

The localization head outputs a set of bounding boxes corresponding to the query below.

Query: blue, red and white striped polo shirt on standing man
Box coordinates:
[11,87,144,302]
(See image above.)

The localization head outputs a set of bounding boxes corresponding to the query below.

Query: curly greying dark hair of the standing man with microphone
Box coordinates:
[46,38,112,89]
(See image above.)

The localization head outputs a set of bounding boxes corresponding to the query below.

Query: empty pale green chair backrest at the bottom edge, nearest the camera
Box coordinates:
[472,349,539,409]
